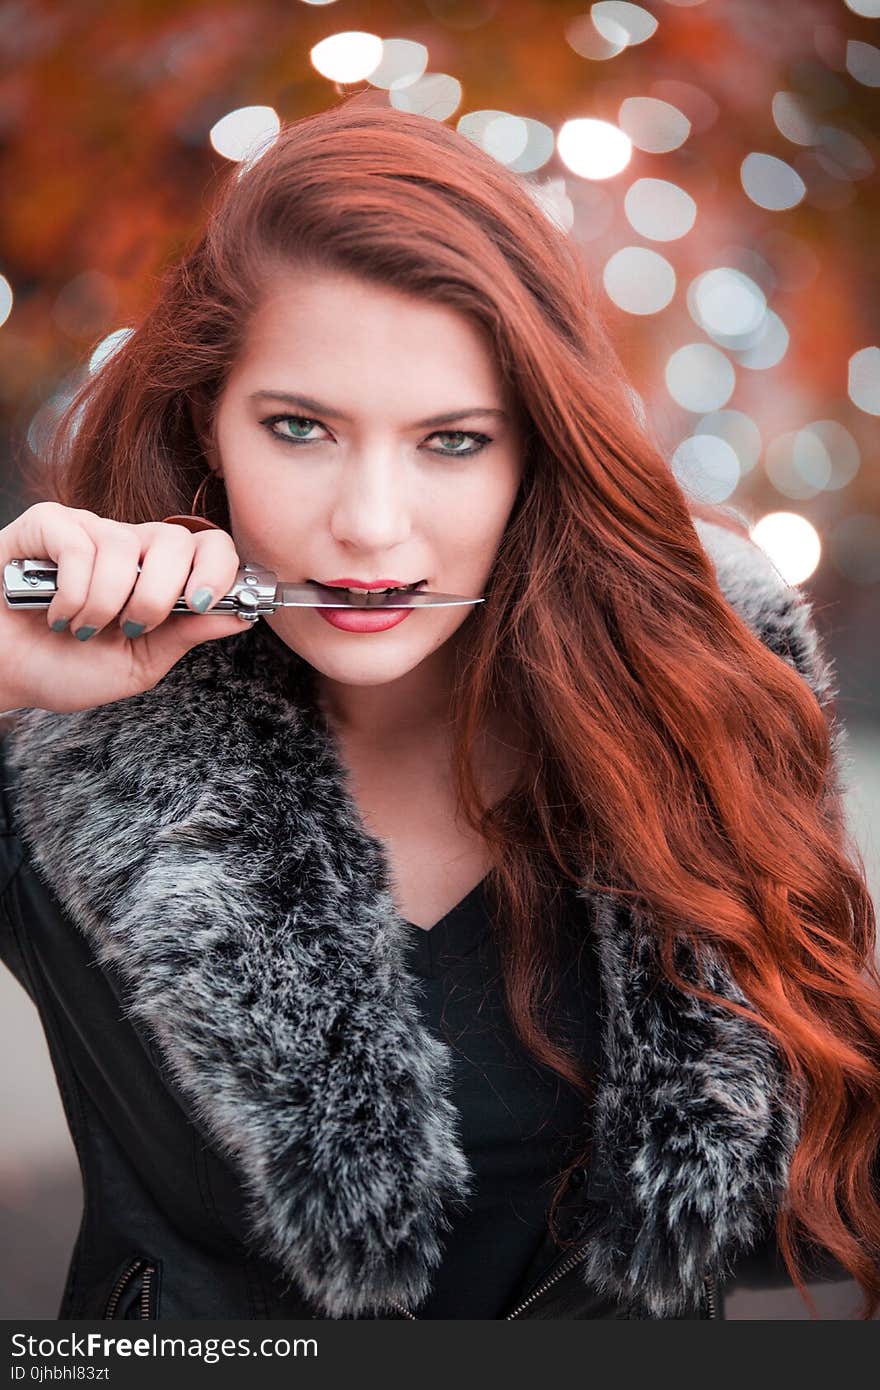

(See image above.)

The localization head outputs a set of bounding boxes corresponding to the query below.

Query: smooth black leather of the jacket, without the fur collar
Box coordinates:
[0,745,689,1319]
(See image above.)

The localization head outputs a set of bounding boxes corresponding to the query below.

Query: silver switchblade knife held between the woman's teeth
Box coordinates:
[3,560,485,623]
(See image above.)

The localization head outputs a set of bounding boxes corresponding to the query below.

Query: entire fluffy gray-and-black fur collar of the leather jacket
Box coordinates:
[7,521,844,1318]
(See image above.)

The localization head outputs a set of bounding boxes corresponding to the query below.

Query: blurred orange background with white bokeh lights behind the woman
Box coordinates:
[0,0,880,1319]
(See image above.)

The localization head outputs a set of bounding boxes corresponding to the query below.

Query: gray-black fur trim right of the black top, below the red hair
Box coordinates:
[572,897,798,1318]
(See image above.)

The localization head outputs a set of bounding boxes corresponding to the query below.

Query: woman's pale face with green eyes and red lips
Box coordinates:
[213,271,523,717]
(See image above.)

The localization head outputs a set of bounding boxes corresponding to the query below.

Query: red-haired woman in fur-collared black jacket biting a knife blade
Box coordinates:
[0,99,880,1318]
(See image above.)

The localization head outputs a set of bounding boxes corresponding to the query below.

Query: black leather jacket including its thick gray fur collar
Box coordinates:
[0,523,867,1319]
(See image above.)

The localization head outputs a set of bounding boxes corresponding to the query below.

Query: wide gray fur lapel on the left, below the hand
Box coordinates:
[3,628,471,1318]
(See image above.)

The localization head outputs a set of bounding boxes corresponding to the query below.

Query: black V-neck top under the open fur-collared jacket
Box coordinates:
[392,880,599,1318]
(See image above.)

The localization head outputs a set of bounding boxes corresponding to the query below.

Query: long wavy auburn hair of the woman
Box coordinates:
[20,93,880,1318]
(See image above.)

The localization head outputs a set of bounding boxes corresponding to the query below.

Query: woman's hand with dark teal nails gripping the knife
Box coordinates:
[0,502,250,710]
